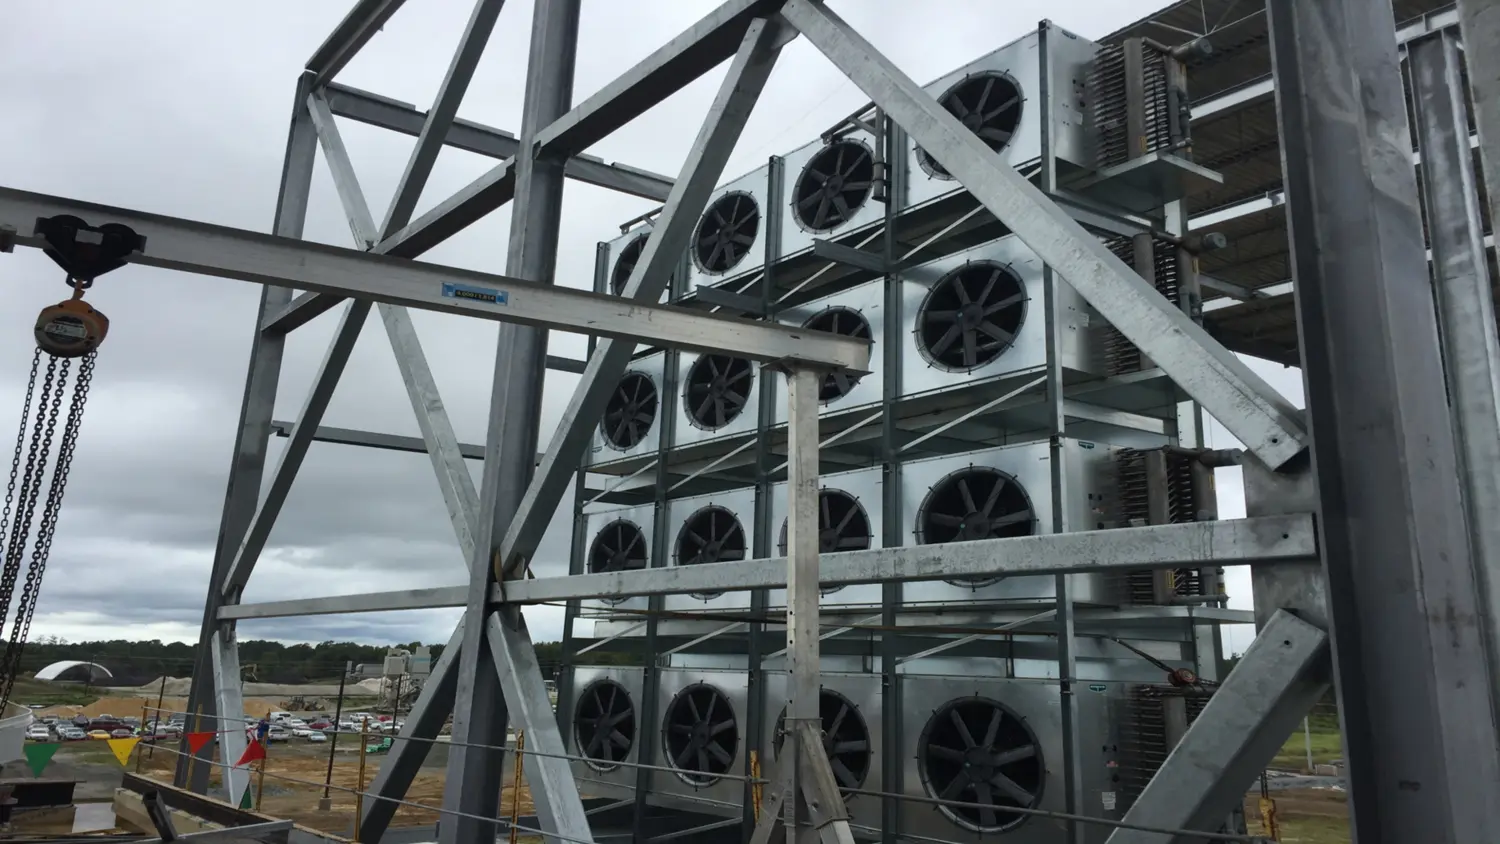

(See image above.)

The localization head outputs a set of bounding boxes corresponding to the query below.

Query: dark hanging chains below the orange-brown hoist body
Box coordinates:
[0,349,95,712]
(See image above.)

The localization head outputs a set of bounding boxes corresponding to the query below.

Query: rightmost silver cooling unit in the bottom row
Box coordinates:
[902,677,1125,844]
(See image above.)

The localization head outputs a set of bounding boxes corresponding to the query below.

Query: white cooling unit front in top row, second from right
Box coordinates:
[780,129,885,255]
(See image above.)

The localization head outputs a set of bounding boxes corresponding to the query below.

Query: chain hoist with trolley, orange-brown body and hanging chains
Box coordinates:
[0,216,146,712]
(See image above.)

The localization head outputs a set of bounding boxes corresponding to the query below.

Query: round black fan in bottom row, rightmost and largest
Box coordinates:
[917,697,1047,832]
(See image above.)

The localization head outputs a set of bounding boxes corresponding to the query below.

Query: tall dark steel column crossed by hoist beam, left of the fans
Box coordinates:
[438,0,587,844]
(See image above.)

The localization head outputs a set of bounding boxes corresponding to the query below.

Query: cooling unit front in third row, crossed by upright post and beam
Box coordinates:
[767,468,884,610]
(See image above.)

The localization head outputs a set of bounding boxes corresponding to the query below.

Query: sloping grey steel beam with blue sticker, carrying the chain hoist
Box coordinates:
[0,187,870,370]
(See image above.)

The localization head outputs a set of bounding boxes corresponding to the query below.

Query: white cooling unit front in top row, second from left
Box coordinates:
[686,166,771,292]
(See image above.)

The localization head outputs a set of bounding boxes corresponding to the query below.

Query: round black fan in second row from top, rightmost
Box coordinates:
[917,261,1026,372]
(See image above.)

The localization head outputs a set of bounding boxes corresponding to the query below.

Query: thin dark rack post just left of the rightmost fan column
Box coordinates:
[878,112,906,844]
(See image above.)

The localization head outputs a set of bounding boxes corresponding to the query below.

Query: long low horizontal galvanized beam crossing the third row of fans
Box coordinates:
[219,514,1317,621]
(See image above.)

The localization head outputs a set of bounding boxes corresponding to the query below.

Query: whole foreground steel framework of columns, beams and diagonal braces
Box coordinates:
[0,0,1500,844]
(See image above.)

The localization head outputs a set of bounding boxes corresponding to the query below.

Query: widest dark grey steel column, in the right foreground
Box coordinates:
[1266,0,1500,844]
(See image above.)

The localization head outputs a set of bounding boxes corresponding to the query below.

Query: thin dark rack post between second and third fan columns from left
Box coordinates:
[741,156,786,840]
